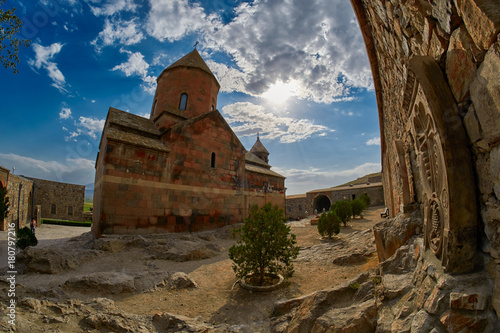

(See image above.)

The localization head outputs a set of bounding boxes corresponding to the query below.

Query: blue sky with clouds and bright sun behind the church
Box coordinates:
[0,0,381,195]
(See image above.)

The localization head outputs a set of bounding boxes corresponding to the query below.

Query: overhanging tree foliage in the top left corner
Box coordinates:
[0,0,31,73]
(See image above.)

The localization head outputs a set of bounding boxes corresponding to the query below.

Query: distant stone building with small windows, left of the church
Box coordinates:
[28,177,85,221]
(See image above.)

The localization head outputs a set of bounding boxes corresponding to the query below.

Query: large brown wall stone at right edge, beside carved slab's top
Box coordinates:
[470,42,500,143]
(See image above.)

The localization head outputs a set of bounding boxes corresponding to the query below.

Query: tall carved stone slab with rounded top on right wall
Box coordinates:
[404,57,477,273]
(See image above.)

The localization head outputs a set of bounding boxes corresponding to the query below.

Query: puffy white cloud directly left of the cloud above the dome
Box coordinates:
[91,19,144,51]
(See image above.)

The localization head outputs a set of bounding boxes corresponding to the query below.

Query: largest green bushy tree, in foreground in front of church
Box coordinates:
[229,203,299,286]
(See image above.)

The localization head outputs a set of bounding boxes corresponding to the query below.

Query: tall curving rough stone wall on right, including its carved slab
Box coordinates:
[351,0,500,322]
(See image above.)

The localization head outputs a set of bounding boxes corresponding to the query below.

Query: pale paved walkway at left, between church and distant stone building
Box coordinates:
[0,224,90,274]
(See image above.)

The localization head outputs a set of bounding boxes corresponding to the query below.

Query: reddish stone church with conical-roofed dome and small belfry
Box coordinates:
[92,49,285,237]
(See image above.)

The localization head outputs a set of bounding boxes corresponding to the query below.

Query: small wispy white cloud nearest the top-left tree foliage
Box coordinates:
[28,43,67,92]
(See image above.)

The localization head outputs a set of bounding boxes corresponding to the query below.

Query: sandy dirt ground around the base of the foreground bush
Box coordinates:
[116,207,382,325]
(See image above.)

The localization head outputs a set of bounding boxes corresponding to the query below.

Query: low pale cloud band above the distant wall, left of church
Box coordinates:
[0,153,95,185]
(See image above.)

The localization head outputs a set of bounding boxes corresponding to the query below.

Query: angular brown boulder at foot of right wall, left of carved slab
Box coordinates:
[373,212,423,262]
